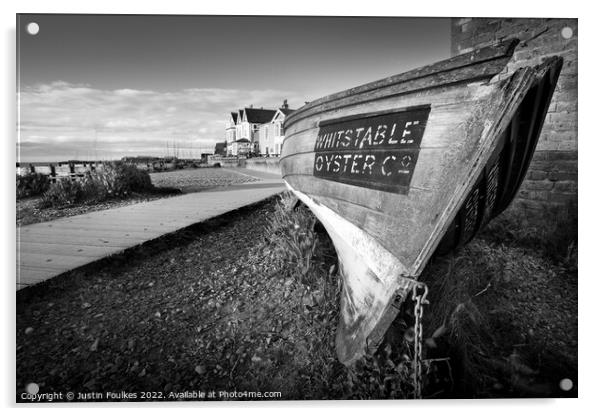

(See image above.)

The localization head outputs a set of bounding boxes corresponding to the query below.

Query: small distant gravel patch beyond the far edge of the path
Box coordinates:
[150,168,259,192]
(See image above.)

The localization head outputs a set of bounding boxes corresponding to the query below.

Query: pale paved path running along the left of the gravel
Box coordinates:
[17,169,285,290]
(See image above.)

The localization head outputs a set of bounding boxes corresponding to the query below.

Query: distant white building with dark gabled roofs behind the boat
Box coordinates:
[226,100,293,156]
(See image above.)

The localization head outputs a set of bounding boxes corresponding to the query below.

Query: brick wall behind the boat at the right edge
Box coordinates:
[451,18,577,210]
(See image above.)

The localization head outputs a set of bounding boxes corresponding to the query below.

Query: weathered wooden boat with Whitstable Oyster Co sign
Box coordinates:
[280,40,562,364]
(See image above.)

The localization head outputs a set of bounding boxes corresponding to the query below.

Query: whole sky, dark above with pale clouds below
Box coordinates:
[17,15,450,162]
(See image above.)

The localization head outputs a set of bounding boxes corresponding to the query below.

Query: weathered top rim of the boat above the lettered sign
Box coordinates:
[283,38,520,129]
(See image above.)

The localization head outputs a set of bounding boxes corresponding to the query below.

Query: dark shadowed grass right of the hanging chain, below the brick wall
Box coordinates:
[422,203,577,397]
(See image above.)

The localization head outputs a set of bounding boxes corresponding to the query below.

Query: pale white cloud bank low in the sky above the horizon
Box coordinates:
[18,81,303,161]
